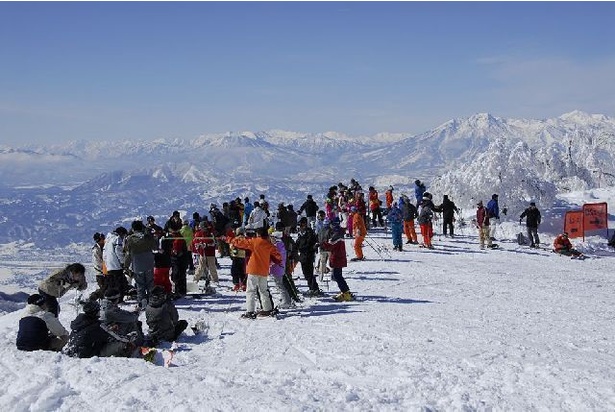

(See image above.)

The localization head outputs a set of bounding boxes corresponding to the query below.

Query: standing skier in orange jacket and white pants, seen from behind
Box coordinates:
[231,227,282,318]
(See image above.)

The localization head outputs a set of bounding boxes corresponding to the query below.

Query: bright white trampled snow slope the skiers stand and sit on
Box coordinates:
[0,188,615,411]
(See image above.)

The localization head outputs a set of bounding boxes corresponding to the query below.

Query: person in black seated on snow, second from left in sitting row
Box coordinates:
[62,301,115,358]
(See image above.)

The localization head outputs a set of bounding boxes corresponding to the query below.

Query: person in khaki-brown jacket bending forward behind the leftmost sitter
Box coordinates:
[38,263,88,317]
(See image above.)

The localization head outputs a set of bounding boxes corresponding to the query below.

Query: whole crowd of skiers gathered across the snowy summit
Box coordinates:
[17,179,560,357]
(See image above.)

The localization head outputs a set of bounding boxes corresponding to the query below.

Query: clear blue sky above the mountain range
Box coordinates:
[0,2,615,144]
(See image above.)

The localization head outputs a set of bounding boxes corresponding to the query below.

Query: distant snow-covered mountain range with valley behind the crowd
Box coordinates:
[0,111,615,247]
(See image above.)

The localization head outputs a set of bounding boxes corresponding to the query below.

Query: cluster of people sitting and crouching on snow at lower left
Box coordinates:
[16,263,188,358]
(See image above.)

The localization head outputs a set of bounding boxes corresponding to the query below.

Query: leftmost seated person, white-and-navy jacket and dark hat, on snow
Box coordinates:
[16,294,68,351]
